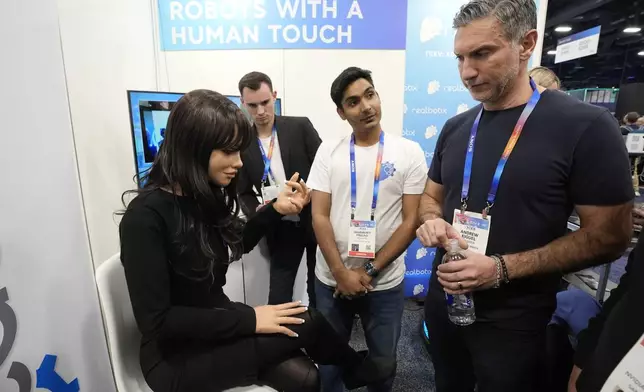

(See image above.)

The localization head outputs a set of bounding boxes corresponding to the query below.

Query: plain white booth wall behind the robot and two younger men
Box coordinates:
[58,0,405,265]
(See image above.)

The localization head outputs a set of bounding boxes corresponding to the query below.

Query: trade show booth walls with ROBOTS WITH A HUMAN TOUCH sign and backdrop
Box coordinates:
[0,0,584,392]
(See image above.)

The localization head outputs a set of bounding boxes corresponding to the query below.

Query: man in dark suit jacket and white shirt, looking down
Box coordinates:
[238,72,322,307]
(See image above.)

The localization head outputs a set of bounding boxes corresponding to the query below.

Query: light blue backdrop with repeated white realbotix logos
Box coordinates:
[403,0,539,298]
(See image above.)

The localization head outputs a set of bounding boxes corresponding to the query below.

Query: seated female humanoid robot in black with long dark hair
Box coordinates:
[120,90,393,392]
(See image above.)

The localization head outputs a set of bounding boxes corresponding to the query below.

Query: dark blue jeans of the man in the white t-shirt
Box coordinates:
[315,278,405,392]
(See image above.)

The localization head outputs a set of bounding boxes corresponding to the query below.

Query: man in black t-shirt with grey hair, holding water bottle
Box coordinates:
[417,0,633,392]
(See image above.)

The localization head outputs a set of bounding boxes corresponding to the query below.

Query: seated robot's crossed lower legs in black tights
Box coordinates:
[256,308,362,392]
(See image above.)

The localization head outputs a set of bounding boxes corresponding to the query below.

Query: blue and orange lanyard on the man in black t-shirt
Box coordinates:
[461,78,541,217]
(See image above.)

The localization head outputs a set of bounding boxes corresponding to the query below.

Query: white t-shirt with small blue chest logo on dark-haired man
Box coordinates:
[307,134,427,290]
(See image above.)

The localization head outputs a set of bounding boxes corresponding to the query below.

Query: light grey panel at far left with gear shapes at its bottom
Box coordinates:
[0,0,114,392]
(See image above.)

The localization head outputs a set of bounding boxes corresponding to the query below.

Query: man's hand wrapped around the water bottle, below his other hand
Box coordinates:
[437,250,496,295]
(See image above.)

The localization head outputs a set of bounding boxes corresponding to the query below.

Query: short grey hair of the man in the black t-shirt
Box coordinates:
[454,0,537,43]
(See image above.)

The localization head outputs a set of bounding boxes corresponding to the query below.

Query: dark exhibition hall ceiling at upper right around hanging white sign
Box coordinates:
[541,0,644,90]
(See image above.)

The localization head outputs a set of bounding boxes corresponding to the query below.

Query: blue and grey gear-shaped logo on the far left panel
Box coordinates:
[0,287,80,392]
